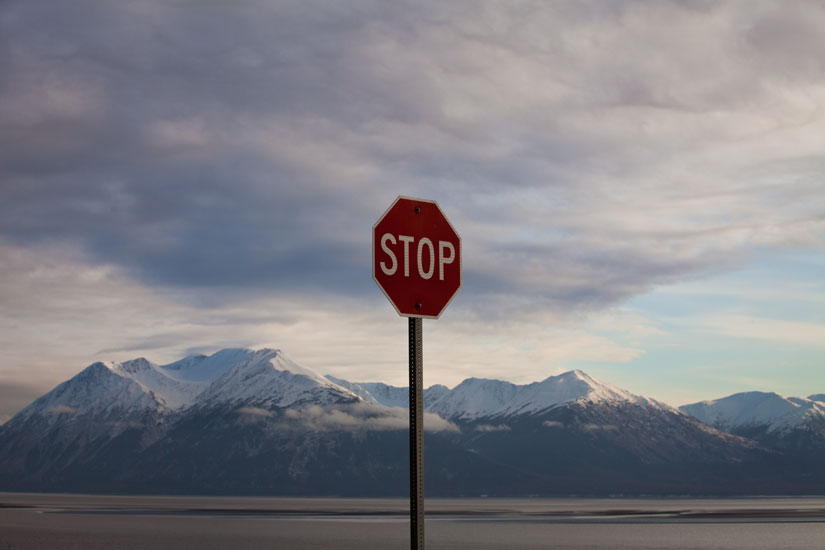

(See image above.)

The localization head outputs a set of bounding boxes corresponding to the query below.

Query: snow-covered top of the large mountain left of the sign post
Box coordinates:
[10,349,358,422]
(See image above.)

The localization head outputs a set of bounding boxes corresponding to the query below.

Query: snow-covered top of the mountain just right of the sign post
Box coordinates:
[427,370,666,419]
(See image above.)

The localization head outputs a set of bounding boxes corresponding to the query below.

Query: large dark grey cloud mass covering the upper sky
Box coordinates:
[0,1,825,322]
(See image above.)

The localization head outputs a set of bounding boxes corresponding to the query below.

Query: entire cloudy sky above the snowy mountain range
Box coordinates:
[0,0,825,420]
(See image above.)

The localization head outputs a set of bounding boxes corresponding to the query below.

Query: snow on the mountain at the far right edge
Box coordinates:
[679,391,825,431]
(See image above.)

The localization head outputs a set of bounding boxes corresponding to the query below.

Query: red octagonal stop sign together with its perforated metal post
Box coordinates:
[372,197,462,550]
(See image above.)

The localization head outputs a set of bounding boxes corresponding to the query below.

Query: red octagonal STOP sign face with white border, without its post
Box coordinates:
[372,197,461,319]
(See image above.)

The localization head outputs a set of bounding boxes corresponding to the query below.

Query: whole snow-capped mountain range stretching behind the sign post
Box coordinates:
[0,349,825,496]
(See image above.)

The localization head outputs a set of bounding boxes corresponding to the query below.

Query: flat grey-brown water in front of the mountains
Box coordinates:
[0,493,825,550]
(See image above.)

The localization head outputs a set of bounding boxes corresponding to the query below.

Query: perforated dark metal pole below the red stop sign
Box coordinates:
[409,317,424,550]
